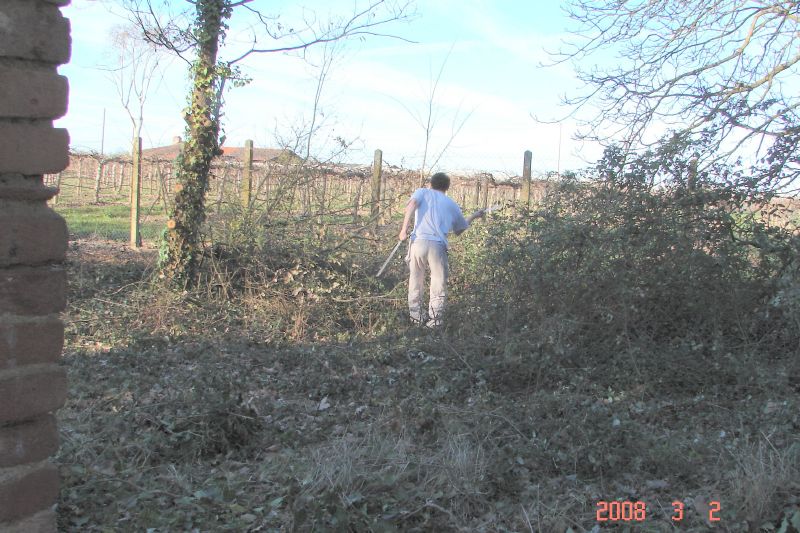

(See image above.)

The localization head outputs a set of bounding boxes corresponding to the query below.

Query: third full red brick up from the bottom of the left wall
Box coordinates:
[0,365,67,424]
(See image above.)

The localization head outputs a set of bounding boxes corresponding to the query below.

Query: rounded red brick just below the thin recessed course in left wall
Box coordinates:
[0,206,67,267]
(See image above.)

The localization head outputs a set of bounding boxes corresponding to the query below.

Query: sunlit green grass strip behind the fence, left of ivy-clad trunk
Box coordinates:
[54,205,166,241]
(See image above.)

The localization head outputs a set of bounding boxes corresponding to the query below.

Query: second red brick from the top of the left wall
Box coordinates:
[0,63,69,119]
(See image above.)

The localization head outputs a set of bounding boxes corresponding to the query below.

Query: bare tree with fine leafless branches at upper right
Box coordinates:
[554,0,800,190]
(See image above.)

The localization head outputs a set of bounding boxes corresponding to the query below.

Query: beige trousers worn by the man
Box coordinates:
[408,239,448,326]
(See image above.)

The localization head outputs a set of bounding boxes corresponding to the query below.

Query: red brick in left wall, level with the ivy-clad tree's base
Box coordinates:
[0,266,67,316]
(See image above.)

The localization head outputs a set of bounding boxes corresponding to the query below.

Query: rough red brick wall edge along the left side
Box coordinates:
[0,0,70,533]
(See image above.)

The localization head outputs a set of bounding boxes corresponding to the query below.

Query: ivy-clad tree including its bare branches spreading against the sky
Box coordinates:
[126,0,418,286]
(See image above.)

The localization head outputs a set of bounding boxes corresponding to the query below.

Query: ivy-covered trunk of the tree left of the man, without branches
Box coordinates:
[161,0,231,287]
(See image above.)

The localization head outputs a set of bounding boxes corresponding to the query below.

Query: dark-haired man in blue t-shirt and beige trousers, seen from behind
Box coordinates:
[399,172,484,328]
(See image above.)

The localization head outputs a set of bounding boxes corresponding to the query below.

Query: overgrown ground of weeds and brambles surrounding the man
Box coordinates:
[56,174,800,532]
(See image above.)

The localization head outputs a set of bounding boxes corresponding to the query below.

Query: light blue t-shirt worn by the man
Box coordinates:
[411,189,469,246]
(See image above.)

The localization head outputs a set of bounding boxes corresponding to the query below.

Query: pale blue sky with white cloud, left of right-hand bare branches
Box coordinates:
[55,0,601,176]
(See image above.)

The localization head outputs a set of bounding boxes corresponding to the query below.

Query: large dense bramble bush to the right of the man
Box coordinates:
[453,135,800,389]
